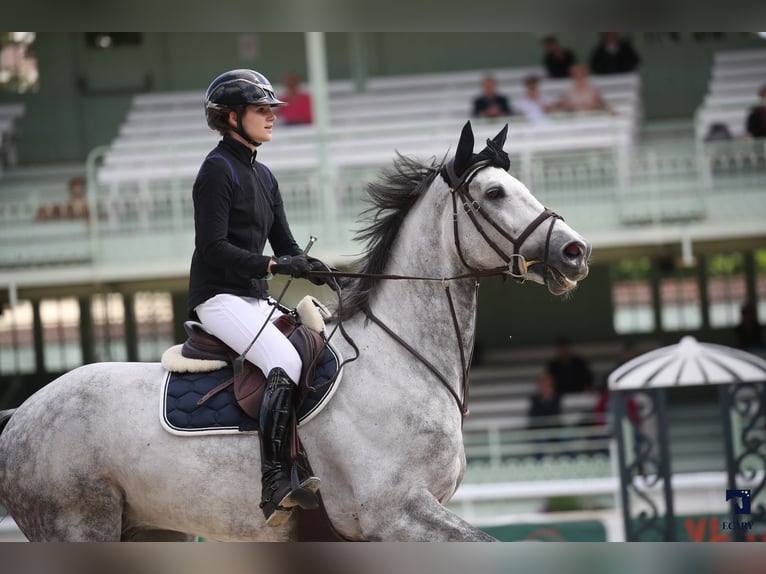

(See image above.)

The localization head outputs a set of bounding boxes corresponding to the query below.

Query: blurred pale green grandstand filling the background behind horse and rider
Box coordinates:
[0,33,766,539]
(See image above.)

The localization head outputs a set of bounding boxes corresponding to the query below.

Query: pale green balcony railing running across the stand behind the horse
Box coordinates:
[0,138,766,276]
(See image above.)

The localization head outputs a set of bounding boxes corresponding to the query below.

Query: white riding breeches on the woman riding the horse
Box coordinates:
[195,294,302,383]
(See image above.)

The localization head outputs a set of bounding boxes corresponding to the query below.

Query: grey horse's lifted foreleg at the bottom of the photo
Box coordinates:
[359,491,495,542]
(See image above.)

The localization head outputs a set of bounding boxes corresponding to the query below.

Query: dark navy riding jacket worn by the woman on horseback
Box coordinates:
[189,135,302,318]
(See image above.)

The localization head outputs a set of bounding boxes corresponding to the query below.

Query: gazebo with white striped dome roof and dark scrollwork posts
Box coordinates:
[608,337,766,541]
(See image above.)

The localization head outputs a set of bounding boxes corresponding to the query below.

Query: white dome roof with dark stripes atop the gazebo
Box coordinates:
[609,337,766,391]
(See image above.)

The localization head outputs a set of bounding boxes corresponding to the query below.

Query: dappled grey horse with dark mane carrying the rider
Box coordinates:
[0,123,590,541]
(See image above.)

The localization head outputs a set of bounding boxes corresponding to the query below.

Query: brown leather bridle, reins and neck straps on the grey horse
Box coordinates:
[309,160,563,424]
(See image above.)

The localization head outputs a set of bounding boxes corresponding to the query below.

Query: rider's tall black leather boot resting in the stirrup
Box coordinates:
[259,368,319,526]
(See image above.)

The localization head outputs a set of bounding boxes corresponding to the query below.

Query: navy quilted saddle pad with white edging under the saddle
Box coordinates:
[161,346,340,434]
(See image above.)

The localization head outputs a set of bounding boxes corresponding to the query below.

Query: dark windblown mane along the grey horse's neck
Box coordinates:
[340,153,442,319]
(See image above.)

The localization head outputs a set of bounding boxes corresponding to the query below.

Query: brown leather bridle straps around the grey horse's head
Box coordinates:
[440,159,564,283]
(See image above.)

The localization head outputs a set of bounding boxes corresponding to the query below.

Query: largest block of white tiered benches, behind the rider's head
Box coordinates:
[98,69,641,186]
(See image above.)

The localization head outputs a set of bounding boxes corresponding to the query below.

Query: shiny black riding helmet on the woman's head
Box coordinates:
[205,69,287,143]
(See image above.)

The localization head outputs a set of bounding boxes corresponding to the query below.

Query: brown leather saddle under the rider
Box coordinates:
[181,315,327,420]
